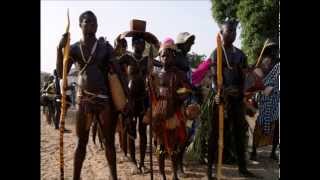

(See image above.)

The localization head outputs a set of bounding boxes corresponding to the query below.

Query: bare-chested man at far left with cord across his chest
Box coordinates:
[57,11,117,180]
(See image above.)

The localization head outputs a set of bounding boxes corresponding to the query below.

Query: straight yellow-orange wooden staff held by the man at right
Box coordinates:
[217,34,224,180]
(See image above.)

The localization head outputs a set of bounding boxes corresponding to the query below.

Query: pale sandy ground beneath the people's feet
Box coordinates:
[41,108,279,180]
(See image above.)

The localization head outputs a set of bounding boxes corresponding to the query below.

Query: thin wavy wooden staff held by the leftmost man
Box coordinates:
[60,9,70,180]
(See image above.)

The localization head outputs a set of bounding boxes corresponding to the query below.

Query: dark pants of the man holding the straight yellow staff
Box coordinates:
[208,100,248,171]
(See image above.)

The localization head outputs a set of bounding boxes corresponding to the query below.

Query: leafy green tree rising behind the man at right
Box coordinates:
[211,0,279,64]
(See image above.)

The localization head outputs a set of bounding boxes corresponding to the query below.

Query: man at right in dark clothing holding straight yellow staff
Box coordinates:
[208,20,255,179]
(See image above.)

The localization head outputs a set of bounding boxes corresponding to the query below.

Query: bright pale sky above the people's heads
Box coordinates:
[41,0,240,73]
